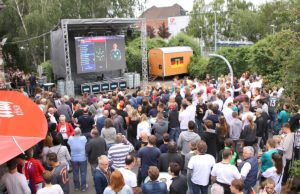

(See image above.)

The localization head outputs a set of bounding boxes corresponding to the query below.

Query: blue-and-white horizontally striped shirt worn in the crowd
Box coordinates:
[108,143,134,169]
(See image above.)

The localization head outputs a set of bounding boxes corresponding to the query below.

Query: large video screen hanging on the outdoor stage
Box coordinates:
[75,36,125,74]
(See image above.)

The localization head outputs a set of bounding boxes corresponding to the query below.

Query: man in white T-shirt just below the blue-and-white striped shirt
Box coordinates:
[118,155,137,193]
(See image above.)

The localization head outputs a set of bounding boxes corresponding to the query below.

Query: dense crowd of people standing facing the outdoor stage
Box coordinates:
[0,72,300,194]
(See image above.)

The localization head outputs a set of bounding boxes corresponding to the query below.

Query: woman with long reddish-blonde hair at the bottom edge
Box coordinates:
[103,170,133,194]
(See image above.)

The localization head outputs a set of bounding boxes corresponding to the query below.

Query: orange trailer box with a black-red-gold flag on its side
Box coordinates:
[148,46,193,77]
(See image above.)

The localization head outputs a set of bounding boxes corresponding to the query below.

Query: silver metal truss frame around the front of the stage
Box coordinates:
[61,18,148,96]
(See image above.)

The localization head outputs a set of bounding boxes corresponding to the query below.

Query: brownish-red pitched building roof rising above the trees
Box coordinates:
[140,3,186,19]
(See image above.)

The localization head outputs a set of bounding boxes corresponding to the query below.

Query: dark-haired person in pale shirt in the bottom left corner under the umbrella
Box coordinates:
[0,159,31,194]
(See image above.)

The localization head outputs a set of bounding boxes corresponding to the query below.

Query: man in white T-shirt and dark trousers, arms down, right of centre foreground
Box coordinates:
[188,141,215,193]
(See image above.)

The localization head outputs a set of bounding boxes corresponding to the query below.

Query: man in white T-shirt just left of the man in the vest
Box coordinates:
[211,149,241,194]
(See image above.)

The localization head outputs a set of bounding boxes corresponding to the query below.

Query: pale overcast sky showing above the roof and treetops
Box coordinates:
[146,0,270,11]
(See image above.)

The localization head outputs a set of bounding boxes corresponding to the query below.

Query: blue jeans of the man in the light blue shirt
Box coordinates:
[72,161,87,189]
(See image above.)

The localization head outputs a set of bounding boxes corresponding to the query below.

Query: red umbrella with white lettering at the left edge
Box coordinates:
[0,91,48,165]
